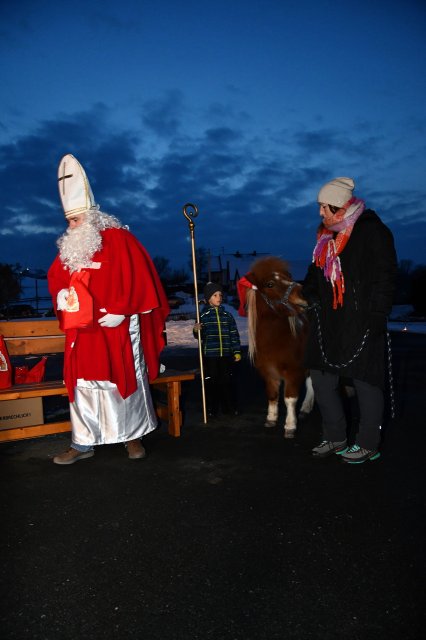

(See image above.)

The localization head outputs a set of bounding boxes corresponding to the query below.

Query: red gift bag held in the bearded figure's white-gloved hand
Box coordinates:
[62,271,93,331]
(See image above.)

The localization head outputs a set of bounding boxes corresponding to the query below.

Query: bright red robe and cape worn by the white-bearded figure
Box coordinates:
[47,229,170,402]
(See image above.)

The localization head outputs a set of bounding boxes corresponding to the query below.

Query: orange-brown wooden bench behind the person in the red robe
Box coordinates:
[0,319,195,442]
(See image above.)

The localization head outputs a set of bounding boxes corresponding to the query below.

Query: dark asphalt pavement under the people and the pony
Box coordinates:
[0,333,426,640]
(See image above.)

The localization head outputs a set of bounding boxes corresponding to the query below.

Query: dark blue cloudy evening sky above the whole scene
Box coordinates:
[0,0,426,268]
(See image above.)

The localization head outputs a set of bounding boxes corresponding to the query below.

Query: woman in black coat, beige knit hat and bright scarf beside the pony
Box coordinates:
[303,178,397,463]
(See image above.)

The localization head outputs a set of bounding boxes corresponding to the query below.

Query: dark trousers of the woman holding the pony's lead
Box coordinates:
[311,369,384,451]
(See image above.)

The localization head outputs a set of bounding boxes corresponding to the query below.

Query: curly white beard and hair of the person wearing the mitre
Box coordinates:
[56,211,126,273]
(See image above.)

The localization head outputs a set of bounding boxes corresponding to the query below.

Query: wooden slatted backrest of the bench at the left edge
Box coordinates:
[0,318,65,356]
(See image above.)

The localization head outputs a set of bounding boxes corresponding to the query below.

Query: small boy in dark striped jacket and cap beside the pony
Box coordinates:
[194,282,241,417]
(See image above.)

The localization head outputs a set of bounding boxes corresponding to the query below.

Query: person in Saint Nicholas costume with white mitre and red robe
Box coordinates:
[48,154,169,464]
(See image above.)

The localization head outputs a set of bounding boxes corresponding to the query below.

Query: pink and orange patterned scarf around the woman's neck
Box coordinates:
[312,197,365,309]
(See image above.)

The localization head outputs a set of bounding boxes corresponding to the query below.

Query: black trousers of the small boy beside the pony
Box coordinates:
[204,356,237,414]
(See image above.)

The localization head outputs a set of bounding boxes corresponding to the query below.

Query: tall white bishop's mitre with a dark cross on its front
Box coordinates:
[58,153,97,218]
